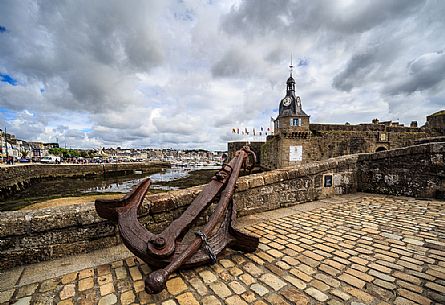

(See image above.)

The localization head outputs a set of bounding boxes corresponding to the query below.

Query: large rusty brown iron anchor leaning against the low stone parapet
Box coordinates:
[95,146,259,294]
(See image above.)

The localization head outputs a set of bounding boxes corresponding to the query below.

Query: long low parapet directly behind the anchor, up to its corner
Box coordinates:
[0,156,357,269]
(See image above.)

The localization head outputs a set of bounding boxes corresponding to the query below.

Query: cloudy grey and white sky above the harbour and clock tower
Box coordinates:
[0,0,445,149]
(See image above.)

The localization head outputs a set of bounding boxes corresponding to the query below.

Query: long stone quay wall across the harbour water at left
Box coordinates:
[0,162,169,200]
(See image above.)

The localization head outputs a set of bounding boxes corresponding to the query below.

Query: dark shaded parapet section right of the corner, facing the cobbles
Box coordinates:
[357,142,445,198]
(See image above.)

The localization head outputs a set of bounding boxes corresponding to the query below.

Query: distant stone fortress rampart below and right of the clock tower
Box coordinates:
[261,124,440,169]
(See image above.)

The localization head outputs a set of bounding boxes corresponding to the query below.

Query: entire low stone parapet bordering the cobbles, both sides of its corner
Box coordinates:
[0,143,445,268]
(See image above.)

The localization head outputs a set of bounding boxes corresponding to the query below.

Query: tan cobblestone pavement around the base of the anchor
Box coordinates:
[0,194,445,305]
